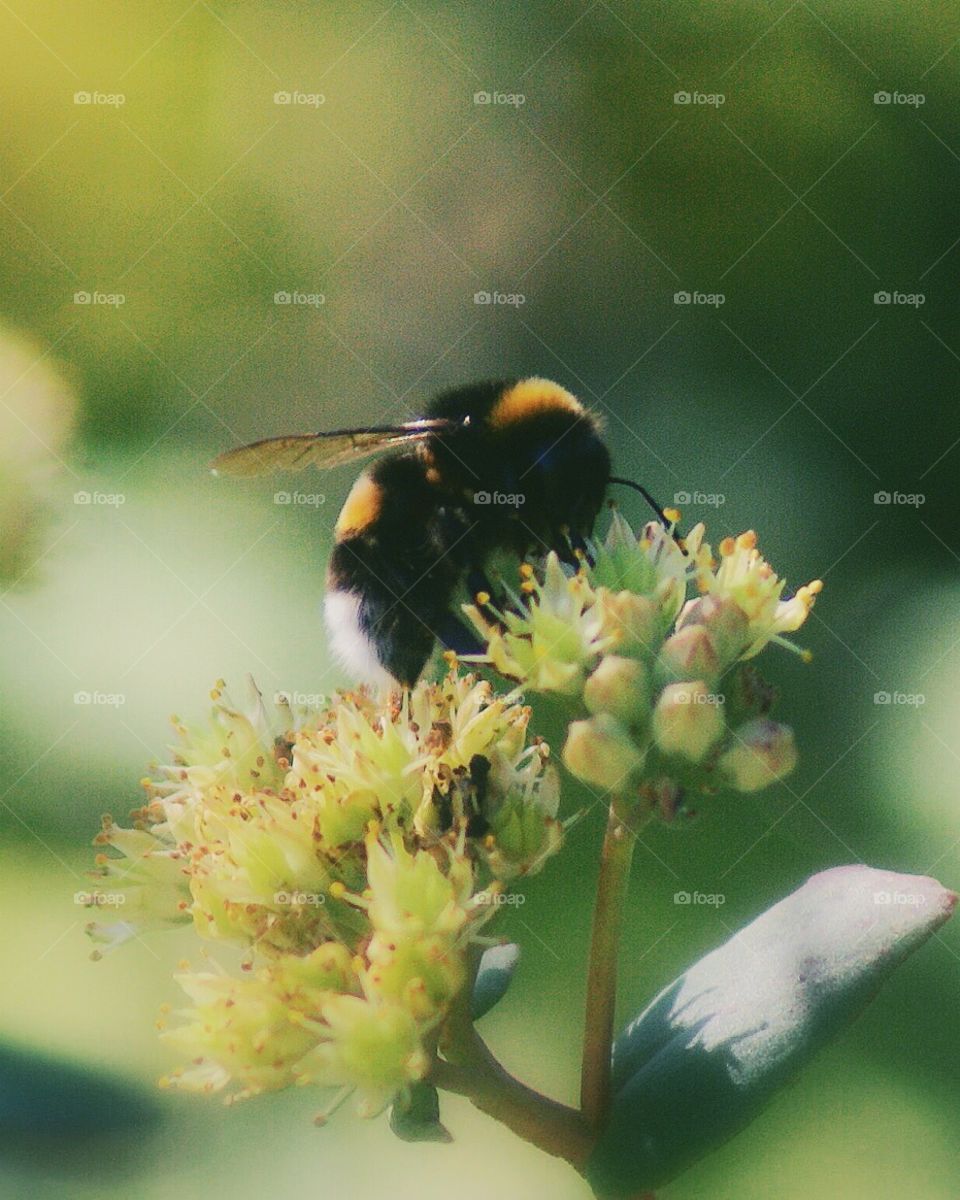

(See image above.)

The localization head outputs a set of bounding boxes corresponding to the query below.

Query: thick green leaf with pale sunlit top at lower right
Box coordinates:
[587,864,958,1200]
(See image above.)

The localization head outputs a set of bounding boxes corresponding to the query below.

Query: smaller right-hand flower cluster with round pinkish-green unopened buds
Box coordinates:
[468,511,822,820]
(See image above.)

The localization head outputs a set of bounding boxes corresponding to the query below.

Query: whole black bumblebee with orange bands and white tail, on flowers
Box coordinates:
[211,378,662,686]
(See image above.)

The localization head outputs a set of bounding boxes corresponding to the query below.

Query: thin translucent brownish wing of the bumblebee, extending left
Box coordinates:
[210,418,462,475]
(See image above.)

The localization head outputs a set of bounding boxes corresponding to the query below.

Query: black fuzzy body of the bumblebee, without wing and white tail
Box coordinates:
[329,380,610,685]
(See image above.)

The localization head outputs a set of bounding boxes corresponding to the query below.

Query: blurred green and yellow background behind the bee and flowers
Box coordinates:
[0,0,960,1200]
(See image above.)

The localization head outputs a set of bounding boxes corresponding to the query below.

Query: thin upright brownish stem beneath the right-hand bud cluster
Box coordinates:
[580,797,636,1130]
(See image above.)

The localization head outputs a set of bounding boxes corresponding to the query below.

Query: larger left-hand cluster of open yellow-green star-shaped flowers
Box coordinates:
[90,674,562,1115]
